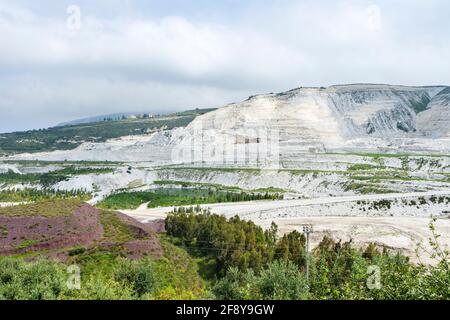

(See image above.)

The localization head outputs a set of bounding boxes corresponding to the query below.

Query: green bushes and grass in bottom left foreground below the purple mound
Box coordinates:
[0,248,205,300]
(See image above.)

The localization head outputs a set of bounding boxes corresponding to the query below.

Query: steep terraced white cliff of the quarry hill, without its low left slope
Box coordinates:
[172,85,450,162]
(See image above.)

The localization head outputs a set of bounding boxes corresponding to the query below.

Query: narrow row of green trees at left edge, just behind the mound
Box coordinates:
[0,188,92,202]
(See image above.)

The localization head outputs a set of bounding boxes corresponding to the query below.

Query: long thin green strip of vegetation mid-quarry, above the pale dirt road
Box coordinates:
[97,188,282,209]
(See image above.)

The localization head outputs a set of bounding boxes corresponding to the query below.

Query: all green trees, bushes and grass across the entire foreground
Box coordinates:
[0,208,450,300]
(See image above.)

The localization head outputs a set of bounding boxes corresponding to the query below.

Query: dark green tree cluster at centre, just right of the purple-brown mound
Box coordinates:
[166,207,306,276]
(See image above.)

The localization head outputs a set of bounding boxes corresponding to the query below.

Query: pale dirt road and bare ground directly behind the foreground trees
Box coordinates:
[122,191,450,263]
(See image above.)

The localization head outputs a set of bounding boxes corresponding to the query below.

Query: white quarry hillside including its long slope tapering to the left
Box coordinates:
[6,84,450,165]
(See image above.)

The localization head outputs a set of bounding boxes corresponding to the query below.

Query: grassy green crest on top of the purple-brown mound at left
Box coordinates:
[0,199,83,218]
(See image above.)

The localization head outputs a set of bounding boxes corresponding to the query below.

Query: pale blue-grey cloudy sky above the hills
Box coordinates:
[0,0,450,132]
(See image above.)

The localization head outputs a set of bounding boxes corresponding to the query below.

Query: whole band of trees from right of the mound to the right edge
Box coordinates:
[166,209,450,299]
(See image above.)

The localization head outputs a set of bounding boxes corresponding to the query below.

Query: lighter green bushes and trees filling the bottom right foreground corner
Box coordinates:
[212,238,450,300]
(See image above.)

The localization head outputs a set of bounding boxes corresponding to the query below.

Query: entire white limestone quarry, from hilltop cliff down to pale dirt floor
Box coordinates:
[0,84,450,264]
